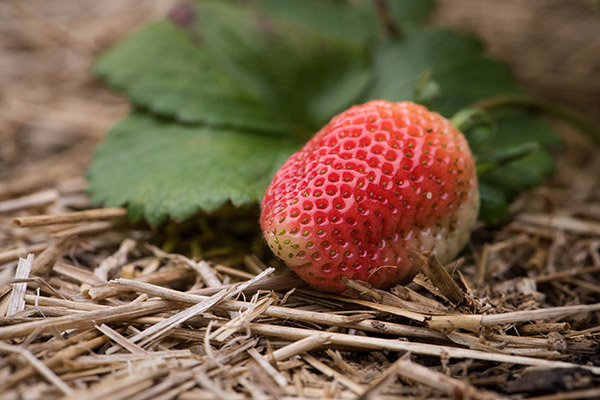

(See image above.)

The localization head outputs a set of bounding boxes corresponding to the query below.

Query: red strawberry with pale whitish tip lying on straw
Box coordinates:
[261,100,479,292]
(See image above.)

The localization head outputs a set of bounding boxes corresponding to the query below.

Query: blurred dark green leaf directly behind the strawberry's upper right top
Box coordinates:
[365,28,519,117]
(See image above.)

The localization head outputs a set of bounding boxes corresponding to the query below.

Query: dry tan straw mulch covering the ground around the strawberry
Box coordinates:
[0,0,600,400]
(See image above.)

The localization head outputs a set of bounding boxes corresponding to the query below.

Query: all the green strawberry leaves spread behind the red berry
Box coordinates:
[89,0,556,223]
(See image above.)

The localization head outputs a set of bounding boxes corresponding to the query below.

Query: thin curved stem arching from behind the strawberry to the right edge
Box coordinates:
[470,94,600,146]
